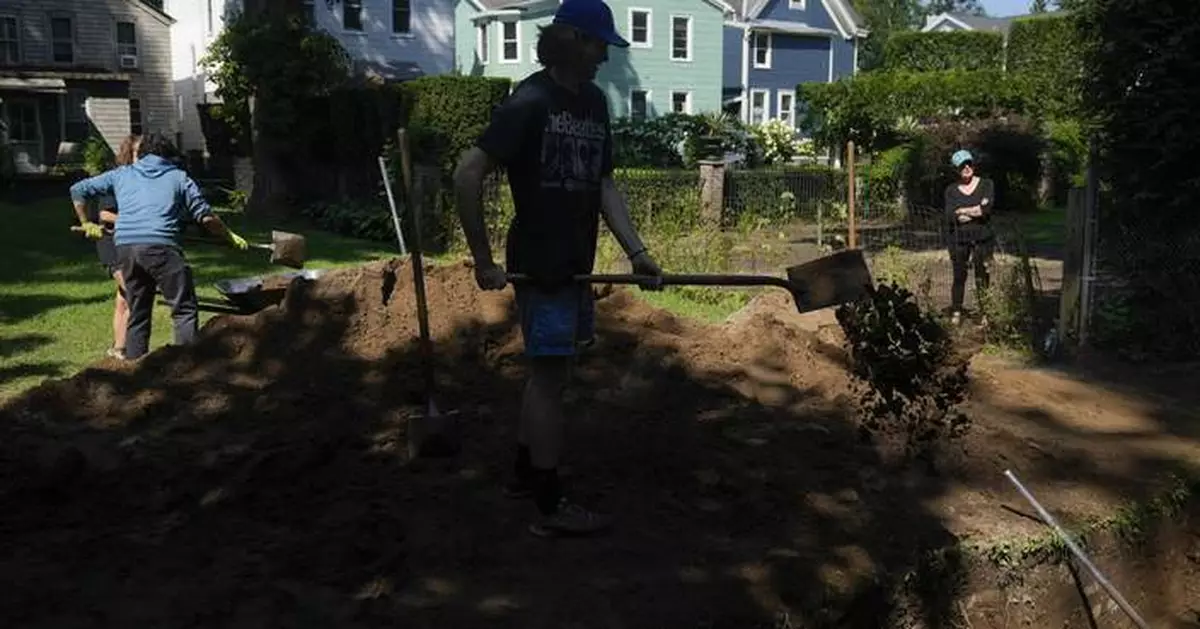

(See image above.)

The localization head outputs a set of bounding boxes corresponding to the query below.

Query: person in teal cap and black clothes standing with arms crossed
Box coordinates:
[944,149,996,325]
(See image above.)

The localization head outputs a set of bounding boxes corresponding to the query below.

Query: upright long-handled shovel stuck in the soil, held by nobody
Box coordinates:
[385,128,460,460]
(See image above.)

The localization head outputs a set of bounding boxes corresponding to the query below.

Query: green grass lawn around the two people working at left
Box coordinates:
[0,194,396,400]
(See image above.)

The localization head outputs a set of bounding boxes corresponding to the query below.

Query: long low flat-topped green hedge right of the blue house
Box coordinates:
[798,70,1028,150]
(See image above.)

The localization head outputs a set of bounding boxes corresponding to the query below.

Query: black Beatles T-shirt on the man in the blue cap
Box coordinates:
[478,70,612,284]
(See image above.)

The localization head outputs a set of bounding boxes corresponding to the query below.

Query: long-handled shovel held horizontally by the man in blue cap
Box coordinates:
[509,248,874,313]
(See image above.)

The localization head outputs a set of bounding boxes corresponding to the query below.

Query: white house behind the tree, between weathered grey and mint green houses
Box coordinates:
[166,0,457,156]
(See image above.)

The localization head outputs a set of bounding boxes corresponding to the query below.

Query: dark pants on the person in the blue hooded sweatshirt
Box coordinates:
[116,245,200,359]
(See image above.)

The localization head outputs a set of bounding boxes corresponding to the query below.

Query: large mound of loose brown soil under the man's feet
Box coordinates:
[0,260,1200,629]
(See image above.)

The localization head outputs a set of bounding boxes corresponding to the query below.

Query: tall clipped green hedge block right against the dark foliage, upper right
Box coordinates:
[1008,14,1084,118]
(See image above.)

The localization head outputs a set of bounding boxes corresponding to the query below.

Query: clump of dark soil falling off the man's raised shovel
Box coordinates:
[836,282,970,466]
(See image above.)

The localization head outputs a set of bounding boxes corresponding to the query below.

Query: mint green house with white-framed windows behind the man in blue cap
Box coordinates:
[455,0,732,118]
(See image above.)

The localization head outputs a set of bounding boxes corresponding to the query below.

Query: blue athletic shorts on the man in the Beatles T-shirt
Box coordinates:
[515,283,595,357]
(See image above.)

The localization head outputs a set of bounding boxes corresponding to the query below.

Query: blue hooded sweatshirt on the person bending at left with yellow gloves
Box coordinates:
[71,155,212,246]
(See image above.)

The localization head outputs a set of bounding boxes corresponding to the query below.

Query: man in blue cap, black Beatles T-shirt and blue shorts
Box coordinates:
[455,0,662,537]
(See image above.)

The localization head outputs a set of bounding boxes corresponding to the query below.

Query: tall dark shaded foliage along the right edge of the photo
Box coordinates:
[1072,0,1200,358]
